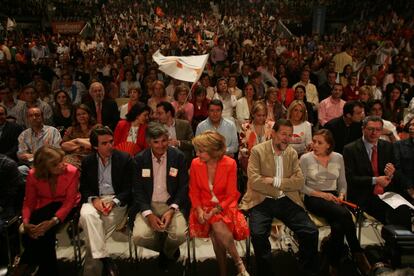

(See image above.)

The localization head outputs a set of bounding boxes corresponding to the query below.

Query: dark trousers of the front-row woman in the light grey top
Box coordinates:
[305,196,362,264]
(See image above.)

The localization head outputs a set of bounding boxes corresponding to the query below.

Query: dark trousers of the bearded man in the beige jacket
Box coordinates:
[250,196,319,276]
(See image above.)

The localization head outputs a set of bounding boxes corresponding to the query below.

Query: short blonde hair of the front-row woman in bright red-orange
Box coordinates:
[193,130,226,160]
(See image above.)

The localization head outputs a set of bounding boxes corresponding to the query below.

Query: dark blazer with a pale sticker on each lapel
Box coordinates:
[130,147,189,221]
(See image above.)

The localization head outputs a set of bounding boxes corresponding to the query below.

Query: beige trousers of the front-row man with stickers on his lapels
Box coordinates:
[132,202,187,258]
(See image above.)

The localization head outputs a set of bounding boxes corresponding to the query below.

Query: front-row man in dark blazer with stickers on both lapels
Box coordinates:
[130,123,188,270]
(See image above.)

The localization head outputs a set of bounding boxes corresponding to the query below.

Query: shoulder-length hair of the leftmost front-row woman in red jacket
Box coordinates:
[33,145,65,180]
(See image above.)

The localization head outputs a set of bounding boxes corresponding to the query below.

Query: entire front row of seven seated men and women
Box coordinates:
[14,116,414,275]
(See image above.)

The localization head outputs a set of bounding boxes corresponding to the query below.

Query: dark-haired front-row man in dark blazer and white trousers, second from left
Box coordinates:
[79,127,137,275]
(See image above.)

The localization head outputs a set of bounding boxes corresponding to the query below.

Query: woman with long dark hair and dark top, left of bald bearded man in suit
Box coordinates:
[53,90,73,133]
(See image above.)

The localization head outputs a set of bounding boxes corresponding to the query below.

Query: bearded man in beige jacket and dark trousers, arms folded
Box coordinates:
[240,119,318,276]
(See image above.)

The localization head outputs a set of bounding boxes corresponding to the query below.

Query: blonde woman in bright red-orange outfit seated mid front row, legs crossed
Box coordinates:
[189,131,249,276]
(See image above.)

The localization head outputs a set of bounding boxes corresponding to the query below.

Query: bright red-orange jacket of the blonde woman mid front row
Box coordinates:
[189,155,240,209]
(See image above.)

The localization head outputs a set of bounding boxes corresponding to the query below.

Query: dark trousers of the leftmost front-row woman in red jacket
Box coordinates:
[21,202,62,276]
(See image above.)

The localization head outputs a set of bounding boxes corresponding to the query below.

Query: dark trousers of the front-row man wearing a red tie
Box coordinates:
[361,195,412,229]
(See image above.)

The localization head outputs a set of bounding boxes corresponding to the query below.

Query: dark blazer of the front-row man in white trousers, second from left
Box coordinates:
[79,150,137,206]
